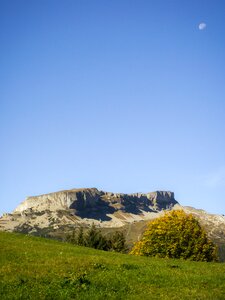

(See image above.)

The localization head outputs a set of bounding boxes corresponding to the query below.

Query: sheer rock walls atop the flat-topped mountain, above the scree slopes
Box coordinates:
[14,188,178,212]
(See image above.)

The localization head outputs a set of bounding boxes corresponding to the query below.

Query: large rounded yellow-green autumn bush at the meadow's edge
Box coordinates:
[130,210,217,261]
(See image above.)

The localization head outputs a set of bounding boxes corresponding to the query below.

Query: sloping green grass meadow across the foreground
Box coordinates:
[0,232,225,300]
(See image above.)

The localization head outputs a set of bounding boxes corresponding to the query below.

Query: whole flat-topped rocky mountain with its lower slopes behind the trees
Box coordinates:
[0,188,225,258]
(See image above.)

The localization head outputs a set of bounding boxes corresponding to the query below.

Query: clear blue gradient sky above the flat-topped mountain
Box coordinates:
[0,0,225,214]
